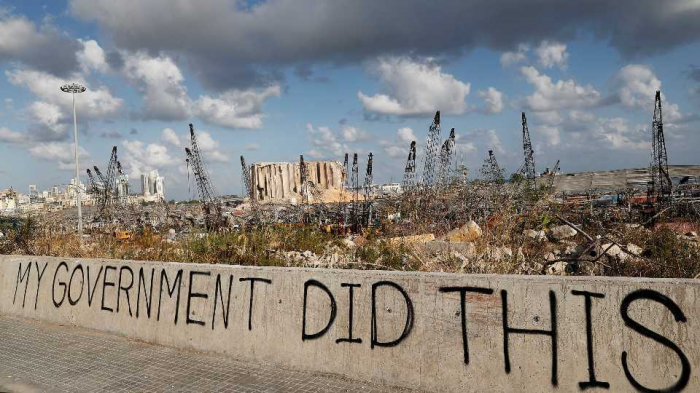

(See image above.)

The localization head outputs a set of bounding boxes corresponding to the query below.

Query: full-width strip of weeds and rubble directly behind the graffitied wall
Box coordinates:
[0,181,700,278]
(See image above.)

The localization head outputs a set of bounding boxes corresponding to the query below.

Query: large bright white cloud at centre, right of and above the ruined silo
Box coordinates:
[357,57,470,116]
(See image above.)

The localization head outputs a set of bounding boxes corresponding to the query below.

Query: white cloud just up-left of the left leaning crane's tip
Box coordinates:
[124,52,192,120]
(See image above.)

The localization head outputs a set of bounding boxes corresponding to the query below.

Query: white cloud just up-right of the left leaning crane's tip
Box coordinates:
[196,85,281,128]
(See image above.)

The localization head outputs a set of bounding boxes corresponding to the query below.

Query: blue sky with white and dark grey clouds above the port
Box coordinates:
[0,0,700,199]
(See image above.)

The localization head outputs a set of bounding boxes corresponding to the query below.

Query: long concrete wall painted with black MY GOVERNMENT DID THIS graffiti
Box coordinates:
[0,256,700,392]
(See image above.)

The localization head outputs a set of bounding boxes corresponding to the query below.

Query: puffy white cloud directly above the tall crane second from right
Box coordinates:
[520,67,601,112]
